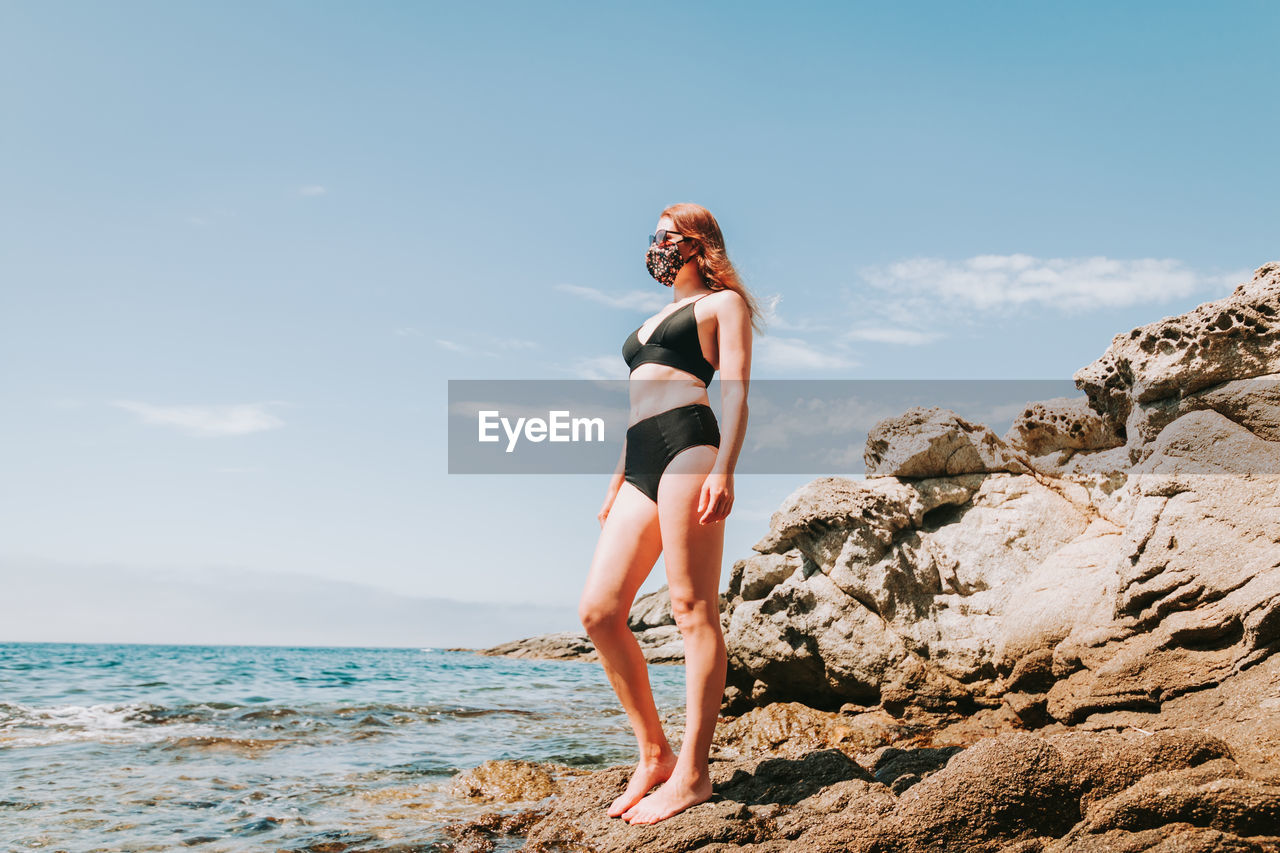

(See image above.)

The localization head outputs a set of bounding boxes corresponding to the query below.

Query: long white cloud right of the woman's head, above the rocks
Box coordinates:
[861,255,1221,313]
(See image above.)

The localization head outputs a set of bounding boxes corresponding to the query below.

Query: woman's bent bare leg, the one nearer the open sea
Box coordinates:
[579,483,676,817]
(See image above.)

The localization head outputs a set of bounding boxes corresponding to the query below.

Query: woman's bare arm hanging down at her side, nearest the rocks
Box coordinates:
[698,293,751,524]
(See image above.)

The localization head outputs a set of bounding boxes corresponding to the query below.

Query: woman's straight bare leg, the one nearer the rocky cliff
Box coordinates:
[623,444,727,824]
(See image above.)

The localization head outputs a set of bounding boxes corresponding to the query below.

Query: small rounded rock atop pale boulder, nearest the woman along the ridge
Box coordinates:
[863,407,1028,478]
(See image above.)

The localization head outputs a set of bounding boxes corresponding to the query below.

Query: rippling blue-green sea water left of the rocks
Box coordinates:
[0,643,685,853]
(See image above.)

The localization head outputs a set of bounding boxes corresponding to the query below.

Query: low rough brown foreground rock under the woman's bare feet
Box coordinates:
[453,731,1280,853]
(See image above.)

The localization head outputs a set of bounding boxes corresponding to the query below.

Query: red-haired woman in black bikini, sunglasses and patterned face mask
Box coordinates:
[579,204,759,824]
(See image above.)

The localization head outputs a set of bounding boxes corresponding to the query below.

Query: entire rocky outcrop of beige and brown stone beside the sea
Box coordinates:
[460,264,1280,853]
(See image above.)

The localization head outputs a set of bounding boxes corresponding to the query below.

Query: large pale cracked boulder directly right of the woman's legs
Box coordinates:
[724,474,1085,713]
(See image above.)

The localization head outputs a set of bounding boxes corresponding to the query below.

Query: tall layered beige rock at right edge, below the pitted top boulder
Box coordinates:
[1048,411,1280,724]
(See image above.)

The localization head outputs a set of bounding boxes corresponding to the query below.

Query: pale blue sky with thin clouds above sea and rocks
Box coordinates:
[0,1,1280,644]
